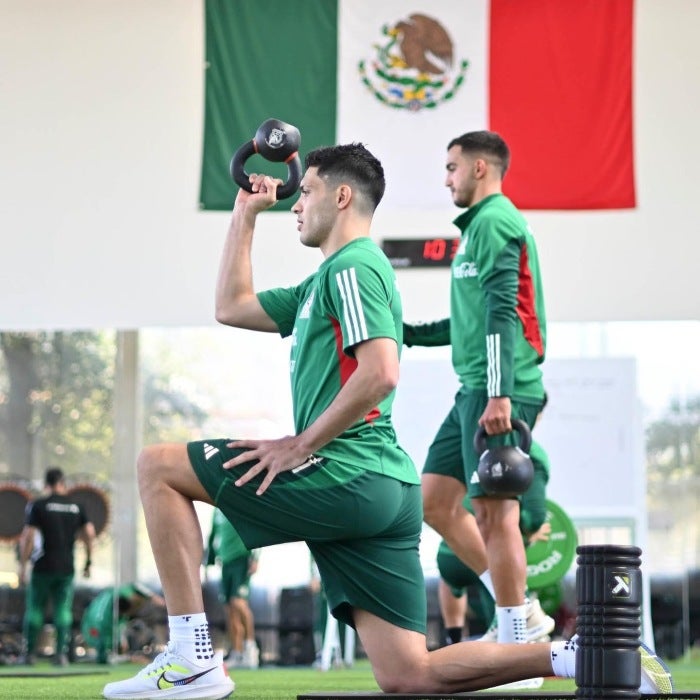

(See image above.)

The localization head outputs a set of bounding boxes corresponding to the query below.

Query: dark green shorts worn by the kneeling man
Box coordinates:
[187,439,427,633]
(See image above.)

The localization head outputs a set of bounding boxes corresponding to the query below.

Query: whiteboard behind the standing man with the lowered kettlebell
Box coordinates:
[393,356,646,524]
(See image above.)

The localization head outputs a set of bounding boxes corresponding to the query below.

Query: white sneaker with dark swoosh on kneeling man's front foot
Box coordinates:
[102,642,234,700]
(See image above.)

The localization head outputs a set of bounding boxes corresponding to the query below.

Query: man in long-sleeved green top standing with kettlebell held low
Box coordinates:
[404,131,546,642]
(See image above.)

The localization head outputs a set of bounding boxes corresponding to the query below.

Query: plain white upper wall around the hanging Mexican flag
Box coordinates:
[0,0,700,330]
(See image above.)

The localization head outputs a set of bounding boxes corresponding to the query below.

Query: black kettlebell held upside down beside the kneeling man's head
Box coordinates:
[230,119,301,199]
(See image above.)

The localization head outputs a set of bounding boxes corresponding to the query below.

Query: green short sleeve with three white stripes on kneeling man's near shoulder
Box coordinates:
[327,255,400,351]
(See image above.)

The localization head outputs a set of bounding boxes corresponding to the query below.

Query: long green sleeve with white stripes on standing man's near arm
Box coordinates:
[474,218,522,398]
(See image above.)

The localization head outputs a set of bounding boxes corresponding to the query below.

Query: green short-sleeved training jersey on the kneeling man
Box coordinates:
[258,238,420,484]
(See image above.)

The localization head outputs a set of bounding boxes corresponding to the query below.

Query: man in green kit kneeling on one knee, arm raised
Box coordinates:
[103,144,668,700]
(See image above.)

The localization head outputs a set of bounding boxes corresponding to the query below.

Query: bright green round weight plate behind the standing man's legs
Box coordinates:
[525,500,578,589]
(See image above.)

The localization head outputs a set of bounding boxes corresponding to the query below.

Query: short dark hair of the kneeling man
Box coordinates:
[305,143,386,214]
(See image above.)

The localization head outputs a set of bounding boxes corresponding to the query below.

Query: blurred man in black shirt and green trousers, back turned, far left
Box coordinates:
[19,467,95,666]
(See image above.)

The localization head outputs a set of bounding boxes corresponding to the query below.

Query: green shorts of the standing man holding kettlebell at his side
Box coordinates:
[423,387,542,498]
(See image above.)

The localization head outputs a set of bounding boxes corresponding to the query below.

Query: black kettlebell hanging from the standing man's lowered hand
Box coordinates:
[474,418,535,498]
